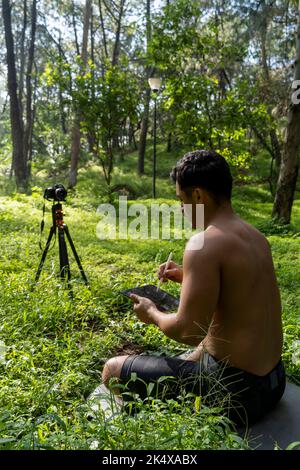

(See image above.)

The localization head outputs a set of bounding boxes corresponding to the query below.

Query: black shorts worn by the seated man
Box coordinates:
[120,353,285,425]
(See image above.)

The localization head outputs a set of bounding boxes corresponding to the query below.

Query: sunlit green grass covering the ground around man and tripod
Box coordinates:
[0,146,300,449]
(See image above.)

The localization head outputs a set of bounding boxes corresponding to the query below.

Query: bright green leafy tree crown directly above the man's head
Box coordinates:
[151,0,274,175]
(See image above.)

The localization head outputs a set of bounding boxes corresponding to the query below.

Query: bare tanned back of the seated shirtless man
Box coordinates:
[189,213,282,376]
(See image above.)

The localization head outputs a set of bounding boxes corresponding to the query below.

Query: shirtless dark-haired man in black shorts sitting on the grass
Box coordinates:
[103,150,285,424]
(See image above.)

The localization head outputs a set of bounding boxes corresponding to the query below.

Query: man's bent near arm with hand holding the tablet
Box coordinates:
[133,235,220,346]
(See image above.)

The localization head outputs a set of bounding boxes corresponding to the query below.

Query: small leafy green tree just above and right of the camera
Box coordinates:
[42,57,138,194]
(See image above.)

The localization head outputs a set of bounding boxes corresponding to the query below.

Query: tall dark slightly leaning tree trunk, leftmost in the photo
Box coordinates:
[2,0,27,191]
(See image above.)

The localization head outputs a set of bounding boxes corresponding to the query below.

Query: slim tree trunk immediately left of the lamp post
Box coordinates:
[137,0,151,175]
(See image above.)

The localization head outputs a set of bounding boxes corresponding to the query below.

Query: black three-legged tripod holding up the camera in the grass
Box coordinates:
[35,203,88,289]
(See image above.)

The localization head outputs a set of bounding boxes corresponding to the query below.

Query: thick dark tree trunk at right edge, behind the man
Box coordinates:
[273,0,300,224]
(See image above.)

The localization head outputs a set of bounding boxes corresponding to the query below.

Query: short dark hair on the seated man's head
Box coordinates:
[170,150,232,203]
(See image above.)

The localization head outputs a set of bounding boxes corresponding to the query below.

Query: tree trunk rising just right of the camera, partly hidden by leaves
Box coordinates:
[69,0,92,188]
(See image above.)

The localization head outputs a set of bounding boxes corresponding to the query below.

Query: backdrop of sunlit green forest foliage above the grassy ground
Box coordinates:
[0,0,297,218]
